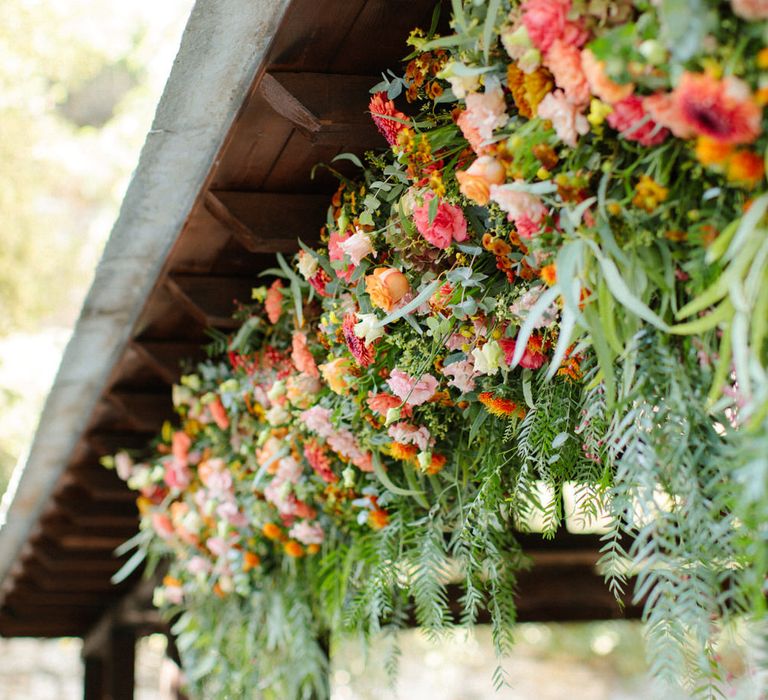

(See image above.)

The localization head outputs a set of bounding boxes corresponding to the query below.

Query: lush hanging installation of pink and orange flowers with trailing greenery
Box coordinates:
[106,0,768,697]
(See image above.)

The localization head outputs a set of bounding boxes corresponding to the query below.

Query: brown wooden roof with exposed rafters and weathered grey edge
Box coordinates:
[0,0,636,637]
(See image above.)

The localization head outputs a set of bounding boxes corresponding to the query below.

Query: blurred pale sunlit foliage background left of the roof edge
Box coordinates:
[0,0,193,492]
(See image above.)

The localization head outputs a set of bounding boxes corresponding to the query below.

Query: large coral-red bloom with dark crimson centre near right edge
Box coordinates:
[673,73,762,144]
